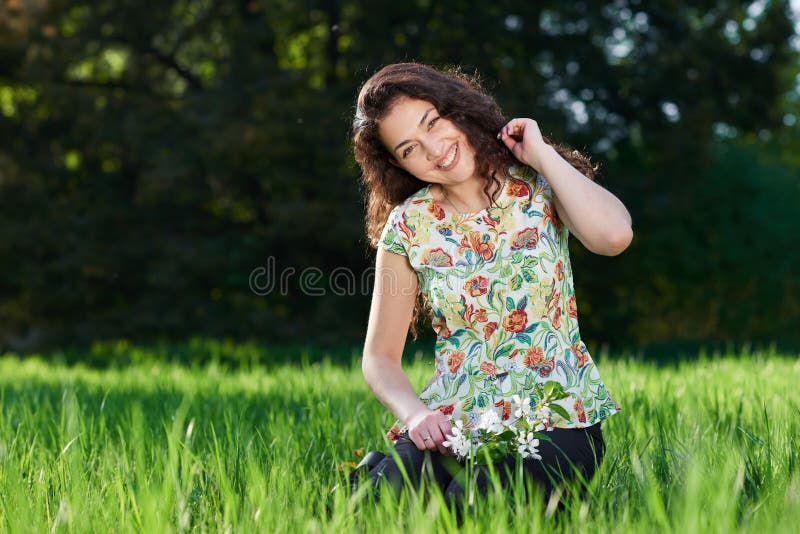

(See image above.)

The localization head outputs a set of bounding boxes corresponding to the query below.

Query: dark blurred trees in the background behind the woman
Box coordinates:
[0,0,800,360]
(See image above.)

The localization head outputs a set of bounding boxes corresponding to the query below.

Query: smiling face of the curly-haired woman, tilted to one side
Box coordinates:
[378,97,475,186]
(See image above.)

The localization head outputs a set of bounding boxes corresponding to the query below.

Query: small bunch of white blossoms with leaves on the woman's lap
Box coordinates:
[443,381,569,465]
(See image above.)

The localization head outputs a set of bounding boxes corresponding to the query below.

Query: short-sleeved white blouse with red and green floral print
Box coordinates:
[378,166,621,440]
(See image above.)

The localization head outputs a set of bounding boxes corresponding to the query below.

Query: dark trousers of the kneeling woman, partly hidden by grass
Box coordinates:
[369,423,605,509]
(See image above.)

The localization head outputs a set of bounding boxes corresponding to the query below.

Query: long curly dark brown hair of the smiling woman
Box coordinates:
[351,63,598,339]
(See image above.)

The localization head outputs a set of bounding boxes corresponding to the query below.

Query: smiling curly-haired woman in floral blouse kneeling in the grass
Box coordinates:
[353,63,633,510]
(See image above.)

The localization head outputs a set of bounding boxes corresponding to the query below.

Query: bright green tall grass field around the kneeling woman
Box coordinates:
[0,346,800,534]
